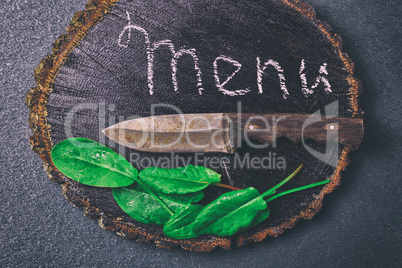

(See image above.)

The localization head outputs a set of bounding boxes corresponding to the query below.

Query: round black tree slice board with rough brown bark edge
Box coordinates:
[26,0,362,251]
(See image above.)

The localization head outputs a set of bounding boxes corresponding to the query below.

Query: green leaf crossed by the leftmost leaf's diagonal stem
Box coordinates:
[113,184,204,226]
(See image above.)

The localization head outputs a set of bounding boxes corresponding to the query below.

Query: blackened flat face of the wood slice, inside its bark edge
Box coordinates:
[33,0,358,251]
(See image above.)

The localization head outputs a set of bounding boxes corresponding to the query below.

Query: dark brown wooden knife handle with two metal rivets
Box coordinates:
[225,114,363,149]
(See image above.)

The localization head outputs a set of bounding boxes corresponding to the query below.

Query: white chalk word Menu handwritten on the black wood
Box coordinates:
[117,11,332,99]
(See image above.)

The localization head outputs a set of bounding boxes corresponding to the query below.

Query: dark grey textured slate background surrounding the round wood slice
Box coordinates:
[0,0,402,267]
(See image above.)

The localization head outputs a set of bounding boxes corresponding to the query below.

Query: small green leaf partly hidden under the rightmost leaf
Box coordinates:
[163,205,204,239]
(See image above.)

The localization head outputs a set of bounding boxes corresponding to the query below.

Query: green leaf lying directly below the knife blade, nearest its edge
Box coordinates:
[139,165,221,194]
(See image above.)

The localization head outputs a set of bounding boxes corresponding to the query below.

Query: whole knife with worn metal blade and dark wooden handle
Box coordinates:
[103,113,363,153]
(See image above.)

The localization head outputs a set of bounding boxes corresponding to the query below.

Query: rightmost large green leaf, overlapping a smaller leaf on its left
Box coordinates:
[193,187,267,236]
